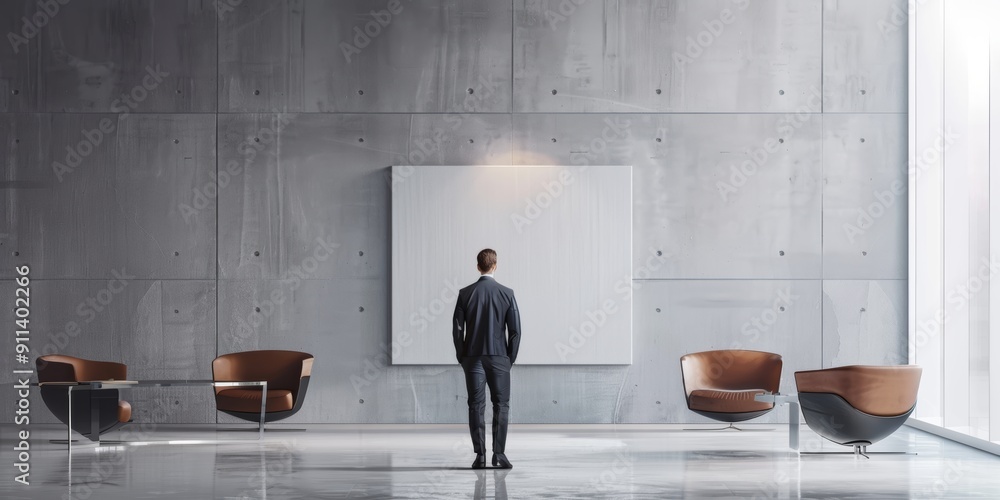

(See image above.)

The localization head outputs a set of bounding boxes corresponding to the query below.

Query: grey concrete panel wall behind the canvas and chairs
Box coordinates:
[0,0,907,423]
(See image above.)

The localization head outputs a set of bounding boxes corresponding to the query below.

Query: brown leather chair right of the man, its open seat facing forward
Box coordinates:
[681,349,781,430]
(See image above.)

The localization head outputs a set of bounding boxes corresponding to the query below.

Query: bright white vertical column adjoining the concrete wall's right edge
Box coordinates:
[909,0,946,425]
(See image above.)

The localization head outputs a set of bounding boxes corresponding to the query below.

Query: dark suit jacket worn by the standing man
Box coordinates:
[452,276,521,364]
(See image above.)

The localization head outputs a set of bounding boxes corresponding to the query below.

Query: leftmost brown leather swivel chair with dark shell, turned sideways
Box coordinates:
[35,354,132,441]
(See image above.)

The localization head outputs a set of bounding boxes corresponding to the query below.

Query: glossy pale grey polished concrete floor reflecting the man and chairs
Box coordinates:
[0,424,1000,500]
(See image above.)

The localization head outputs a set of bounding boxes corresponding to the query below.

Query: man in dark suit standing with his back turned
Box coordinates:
[452,248,521,469]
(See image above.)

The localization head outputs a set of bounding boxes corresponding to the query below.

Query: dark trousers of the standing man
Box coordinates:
[462,356,510,454]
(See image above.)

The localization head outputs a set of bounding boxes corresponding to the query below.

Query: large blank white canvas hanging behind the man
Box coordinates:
[392,166,632,365]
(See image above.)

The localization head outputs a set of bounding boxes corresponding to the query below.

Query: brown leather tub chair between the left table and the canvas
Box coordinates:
[212,351,314,422]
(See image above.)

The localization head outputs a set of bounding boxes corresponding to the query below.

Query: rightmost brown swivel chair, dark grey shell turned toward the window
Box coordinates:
[795,365,922,458]
